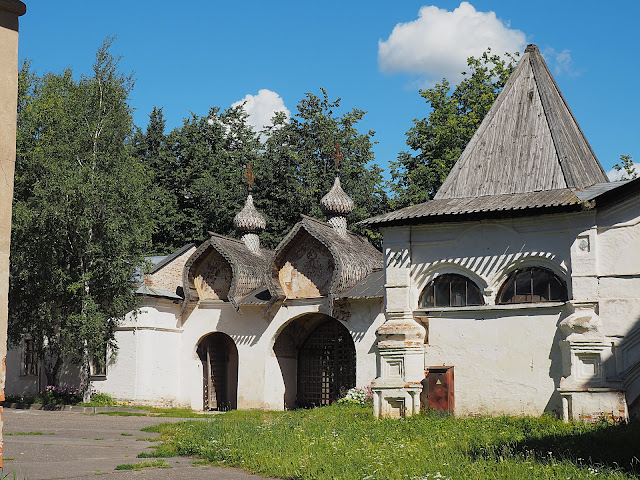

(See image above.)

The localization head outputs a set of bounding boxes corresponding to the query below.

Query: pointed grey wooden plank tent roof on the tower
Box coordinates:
[434,45,608,200]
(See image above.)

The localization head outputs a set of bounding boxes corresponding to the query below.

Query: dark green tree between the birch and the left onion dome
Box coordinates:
[133,103,260,253]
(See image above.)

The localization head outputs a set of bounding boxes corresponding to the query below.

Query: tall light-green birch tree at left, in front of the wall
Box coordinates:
[9,38,152,384]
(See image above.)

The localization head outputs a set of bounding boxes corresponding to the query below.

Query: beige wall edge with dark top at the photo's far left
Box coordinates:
[0,0,27,467]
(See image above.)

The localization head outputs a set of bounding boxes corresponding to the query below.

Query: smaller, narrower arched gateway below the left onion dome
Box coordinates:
[198,332,238,411]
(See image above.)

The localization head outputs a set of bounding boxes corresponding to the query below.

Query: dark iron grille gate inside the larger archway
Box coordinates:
[297,320,356,408]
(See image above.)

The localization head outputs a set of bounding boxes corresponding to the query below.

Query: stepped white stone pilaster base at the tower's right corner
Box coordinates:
[558,304,628,422]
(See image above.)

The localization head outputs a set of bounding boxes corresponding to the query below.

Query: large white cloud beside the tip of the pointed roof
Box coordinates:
[378,2,526,83]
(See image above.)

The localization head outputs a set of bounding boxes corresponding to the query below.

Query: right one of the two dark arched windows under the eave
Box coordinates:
[497,267,567,304]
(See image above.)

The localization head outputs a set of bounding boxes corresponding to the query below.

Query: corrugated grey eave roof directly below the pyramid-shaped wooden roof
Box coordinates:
[360,188,582,226]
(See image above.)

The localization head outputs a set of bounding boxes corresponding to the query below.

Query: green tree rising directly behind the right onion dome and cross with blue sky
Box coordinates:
[254,89,388,246]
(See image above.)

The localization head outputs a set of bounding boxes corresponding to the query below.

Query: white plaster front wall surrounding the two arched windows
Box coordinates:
[383,212,597,415]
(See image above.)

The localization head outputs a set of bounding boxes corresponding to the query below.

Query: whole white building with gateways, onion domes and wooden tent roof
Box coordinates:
[7,45,640,420]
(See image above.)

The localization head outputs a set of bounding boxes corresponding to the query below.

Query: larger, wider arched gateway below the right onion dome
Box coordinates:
[273,313,356,408]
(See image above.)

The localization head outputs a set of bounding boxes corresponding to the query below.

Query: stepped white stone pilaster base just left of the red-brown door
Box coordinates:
[371,311,426,418]
